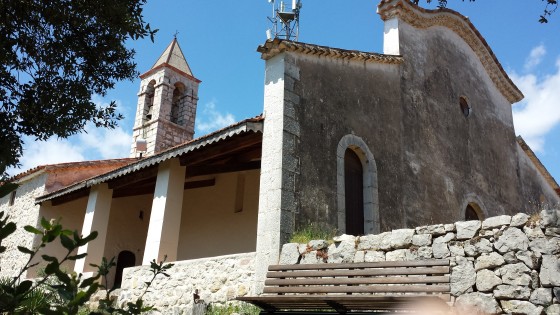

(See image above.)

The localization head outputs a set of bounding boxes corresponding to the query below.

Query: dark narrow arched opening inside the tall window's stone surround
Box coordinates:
[344,149,364,235]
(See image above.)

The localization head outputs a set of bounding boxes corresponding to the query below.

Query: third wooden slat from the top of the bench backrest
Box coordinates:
[264,276,449,286]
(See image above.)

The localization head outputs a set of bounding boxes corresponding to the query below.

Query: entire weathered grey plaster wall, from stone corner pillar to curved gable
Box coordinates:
[278,23,546,235]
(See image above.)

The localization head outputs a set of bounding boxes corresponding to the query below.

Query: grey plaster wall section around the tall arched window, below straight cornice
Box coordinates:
[288,53,405,233]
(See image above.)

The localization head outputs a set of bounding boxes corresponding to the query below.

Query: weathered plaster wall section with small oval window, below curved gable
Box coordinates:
[399,23,525,226]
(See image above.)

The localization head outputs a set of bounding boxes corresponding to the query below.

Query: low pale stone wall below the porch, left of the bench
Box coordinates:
[118,253,255,314]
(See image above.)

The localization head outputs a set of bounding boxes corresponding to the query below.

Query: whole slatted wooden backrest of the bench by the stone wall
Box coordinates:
[263,259,450,300]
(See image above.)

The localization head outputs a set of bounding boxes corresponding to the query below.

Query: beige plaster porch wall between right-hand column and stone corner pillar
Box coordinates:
[177,170,260,260]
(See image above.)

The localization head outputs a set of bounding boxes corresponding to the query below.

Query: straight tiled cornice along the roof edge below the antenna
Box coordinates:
[257,38,403,64]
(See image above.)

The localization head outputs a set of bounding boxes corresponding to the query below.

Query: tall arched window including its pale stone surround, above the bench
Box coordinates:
[336,135,379,235]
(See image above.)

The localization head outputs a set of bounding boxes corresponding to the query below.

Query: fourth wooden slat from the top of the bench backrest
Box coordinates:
[263,284,450,293]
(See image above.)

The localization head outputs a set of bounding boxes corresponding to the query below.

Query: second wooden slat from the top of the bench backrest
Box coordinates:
[266,264,449,278]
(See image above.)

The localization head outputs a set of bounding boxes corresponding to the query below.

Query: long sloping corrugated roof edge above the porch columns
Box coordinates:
[35,116,264,203]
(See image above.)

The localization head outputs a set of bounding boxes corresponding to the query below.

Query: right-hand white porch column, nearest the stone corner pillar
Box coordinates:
[142,159,185,265]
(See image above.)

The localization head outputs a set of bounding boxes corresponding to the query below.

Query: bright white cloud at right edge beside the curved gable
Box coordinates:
[511,52,560,152]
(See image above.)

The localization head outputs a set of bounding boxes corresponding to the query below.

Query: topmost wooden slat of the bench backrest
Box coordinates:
[268,259,449,271]
